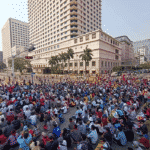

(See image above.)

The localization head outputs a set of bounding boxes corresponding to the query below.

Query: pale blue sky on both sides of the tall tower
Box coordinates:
[0,0,150,51]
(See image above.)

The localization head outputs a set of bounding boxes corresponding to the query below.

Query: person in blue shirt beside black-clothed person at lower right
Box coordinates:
[114,127,127,146]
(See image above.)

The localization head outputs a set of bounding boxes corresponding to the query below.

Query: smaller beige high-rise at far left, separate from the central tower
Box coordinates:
[2,18,29,66]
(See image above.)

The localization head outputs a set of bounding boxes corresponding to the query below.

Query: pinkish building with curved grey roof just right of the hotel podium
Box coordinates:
[115,36,134,66]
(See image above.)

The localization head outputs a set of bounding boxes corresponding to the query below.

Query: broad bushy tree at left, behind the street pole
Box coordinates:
[8,57,31,73]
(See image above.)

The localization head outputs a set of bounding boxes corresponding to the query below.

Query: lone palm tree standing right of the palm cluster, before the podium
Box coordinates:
[79,47,93,73]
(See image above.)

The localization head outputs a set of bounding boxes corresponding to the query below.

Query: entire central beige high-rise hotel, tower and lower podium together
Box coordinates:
[28,0,121,73]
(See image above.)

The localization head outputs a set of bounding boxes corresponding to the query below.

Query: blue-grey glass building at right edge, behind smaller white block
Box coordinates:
[133,39,150,61]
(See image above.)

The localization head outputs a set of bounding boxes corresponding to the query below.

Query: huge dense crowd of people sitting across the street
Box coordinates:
[0,75,150,150]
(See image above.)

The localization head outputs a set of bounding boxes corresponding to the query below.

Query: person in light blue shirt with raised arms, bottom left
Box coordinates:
[17,132,32,150]
